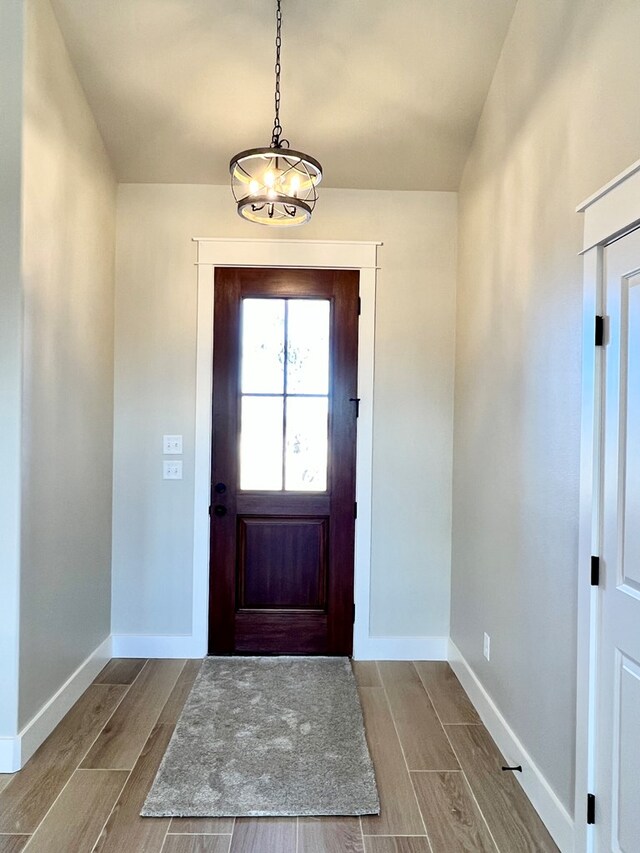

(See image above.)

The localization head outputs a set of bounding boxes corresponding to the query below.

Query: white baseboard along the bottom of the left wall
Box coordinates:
[0,637,111,773]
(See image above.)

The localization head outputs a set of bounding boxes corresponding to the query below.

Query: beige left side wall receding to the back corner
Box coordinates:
[19,0,116,725]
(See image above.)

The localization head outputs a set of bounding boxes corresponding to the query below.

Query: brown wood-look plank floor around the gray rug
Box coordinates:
[0,660,557,853]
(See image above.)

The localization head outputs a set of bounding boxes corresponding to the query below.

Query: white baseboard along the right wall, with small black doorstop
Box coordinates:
[449,640,575,853]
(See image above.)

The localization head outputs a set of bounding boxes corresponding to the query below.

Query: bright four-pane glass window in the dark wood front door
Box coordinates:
[240,298,331,492]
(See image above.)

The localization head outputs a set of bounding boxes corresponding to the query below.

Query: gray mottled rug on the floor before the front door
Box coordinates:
[141,657,380,817]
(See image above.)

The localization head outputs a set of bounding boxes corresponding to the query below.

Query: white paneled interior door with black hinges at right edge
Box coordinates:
[595,230,640,853]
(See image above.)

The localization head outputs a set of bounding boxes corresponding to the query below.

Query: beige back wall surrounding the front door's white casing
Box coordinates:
[113,184,457,636]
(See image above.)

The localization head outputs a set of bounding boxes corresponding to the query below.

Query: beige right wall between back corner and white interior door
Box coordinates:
[452,0,640,811]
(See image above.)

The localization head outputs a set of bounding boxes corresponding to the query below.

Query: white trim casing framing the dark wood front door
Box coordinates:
[188,237,381,659]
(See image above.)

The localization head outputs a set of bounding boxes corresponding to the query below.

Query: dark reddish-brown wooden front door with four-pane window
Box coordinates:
[209,268,359,655]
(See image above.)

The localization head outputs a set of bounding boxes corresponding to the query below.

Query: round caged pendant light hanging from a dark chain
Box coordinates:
[229,0,322,226]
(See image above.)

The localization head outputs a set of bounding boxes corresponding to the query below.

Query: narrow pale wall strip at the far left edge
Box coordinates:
[0,0,24,738]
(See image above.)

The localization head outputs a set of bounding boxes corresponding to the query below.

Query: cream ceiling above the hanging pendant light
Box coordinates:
[52,0,516,190]
